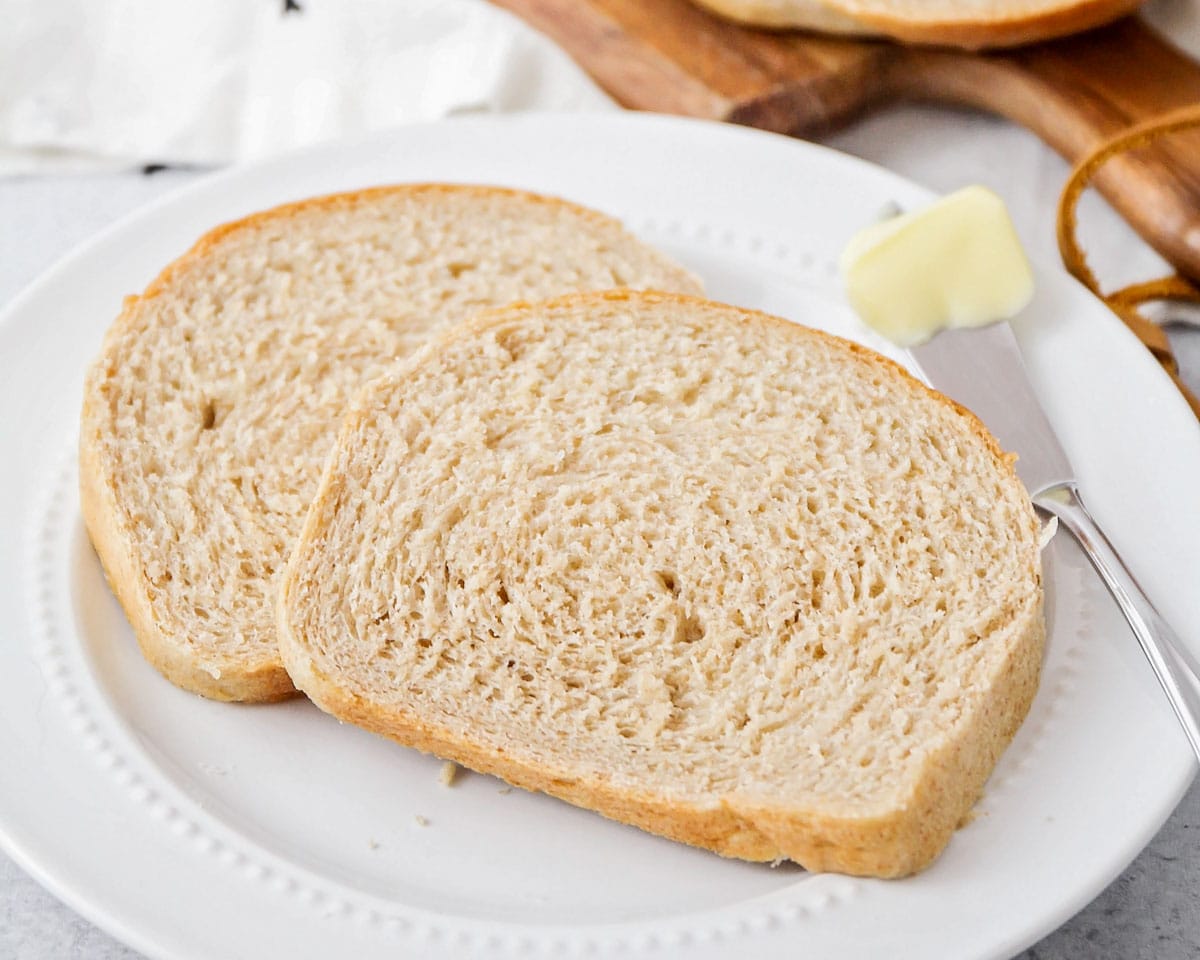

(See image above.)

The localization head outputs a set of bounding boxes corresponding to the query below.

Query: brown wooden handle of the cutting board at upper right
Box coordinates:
[884,18,1200,278]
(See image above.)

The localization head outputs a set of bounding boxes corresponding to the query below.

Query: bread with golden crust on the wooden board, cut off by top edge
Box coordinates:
[698,0,1142,49]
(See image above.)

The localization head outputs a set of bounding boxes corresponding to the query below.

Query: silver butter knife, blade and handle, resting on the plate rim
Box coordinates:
[910,322,1200,757]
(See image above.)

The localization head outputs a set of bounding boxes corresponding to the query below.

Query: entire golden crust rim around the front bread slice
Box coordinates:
[277,290,1045,877]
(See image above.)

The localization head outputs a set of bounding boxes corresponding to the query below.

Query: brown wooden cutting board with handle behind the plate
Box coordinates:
[496,0,1200,278]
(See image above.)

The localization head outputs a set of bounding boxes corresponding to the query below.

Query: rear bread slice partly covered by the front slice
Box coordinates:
[79,185,698,701]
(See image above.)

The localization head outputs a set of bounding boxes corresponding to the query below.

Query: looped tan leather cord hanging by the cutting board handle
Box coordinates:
[1057,103,1200,416]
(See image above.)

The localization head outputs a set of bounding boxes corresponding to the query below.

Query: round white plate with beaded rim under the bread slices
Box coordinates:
[0,115,1200,960]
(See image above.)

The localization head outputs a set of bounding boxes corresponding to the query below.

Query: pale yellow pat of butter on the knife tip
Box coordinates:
[840,186,1033,347]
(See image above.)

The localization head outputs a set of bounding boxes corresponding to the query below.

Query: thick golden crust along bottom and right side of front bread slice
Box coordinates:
[280,601,1043,878]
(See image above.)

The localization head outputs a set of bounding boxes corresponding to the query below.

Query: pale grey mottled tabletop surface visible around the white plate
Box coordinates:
[0,107,1200,960]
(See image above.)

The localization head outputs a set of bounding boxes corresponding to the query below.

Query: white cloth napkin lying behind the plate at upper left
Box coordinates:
[0,0,614,175]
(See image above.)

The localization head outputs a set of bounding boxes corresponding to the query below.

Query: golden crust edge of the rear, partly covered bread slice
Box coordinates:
[79,182,698,702]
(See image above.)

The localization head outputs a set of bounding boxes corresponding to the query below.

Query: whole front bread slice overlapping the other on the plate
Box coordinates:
[280,292,1044,876]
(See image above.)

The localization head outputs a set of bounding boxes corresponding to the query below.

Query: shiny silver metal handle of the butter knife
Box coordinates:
[1033,484,1200,757]
